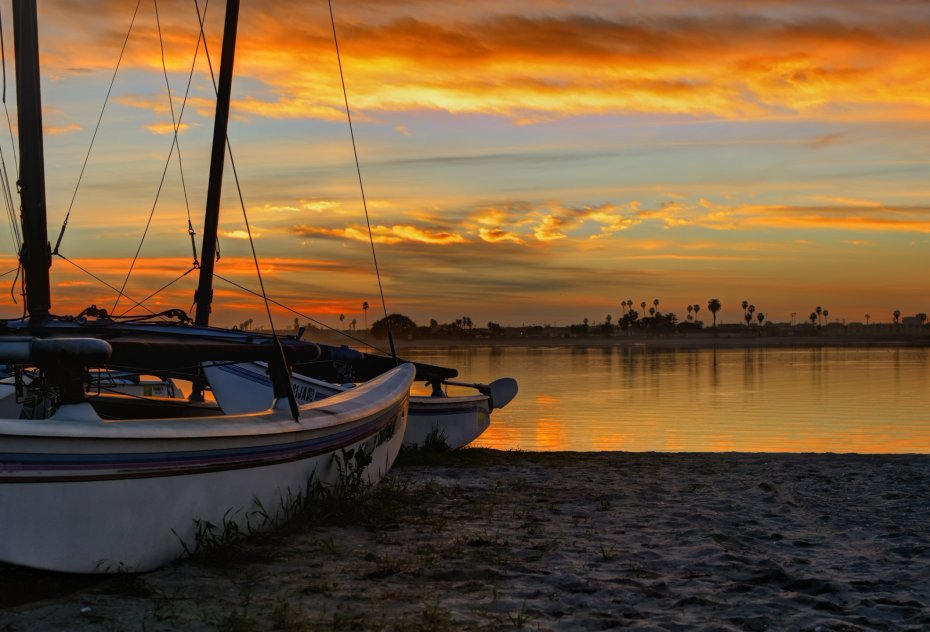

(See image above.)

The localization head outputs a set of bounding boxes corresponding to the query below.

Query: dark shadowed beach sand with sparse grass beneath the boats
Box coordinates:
[0,450,930,631]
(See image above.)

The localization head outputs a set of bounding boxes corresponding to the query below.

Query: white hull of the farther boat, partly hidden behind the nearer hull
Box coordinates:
[204,362,491,450]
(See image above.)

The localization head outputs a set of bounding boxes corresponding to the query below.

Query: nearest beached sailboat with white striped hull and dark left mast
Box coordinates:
[0,0,415,573]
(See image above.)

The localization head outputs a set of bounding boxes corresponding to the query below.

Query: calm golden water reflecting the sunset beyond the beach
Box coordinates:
[405,347,930,453]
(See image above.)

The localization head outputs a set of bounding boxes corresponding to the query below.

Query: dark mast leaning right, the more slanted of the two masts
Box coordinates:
[194,0,239,326]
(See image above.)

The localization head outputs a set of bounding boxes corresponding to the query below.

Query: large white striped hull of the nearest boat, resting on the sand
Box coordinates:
[0,365,413,573]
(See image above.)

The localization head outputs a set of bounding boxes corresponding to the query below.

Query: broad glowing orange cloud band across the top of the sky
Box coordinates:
[36,0,930,123]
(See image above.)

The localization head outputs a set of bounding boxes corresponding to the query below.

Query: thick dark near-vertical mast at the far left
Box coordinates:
[13,0,52,322]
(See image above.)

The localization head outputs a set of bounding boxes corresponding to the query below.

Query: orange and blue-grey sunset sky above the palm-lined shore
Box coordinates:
[0,0,930,327]
